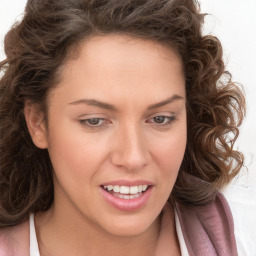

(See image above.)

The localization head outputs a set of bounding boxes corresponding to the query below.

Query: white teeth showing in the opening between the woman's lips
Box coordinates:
[102,185,150,200]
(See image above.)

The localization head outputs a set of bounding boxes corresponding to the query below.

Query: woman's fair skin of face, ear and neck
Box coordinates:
[25,35,186,256]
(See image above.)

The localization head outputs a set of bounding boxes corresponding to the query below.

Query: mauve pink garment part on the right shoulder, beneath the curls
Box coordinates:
[176,192,238,256]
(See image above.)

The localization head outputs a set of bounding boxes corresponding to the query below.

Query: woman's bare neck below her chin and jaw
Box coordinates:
[35,205,161,256]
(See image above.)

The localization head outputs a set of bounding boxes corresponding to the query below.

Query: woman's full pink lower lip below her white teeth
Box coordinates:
[101,186,152,211]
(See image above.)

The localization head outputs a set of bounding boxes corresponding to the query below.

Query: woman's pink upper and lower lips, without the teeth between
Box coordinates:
[100,180,153,211]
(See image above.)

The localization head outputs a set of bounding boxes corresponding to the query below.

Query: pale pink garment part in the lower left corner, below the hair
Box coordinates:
[0,220,29,256]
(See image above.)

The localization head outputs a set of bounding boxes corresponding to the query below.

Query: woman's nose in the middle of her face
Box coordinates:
[111,125,150,171]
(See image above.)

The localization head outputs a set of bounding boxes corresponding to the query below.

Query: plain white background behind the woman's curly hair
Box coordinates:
[0,0,256,188]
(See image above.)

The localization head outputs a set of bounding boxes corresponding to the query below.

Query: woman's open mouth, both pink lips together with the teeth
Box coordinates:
[100,181,153,211]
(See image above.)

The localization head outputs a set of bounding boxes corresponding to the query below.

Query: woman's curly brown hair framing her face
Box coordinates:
[0,0,245,227]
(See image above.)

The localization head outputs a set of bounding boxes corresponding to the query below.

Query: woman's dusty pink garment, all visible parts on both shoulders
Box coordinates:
[0,193,237,256]
